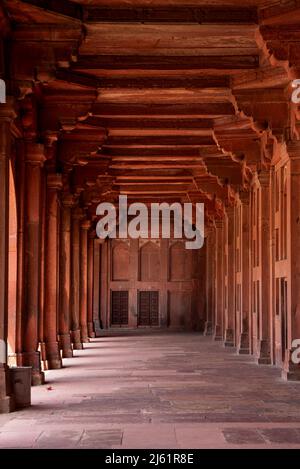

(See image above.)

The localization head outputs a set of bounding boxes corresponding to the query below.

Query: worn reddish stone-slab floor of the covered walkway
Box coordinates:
[0,333,300,449]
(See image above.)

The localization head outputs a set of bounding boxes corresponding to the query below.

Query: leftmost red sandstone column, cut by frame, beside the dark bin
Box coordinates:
[0,104,15,413]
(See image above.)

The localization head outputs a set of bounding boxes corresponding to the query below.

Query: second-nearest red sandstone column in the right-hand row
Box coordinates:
[257,170,271,365]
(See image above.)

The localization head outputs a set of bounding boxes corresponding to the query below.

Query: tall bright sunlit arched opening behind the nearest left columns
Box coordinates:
[8,160,18,365]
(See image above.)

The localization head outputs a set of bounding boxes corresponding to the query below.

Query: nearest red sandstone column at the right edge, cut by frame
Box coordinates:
[282,142,300,381]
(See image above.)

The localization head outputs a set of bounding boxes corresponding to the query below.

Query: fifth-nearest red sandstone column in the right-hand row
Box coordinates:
[214,220,224,340]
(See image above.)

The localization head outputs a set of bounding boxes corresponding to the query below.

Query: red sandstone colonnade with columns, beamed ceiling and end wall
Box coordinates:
[0,0,300,412]
